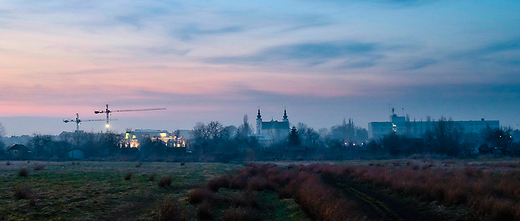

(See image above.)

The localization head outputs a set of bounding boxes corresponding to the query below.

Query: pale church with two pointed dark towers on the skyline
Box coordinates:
[255,108,290,145]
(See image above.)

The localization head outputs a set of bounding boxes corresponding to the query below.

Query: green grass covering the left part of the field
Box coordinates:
[0,161,303,220]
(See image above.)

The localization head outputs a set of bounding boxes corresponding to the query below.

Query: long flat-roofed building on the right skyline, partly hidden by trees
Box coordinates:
[368,109,500,139]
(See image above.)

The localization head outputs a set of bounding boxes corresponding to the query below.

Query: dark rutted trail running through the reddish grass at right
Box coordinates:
[322,177,444,221]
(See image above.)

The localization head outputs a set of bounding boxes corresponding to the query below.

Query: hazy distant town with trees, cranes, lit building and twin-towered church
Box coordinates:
[0,108,520,161]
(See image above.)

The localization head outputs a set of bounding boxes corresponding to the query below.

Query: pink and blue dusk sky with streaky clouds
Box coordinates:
[0,0,520,136]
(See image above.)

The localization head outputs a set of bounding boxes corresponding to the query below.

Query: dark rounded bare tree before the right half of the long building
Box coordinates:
[424,117,471,156]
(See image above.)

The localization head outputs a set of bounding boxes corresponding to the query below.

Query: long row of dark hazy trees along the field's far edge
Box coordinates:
[0,119,520,160]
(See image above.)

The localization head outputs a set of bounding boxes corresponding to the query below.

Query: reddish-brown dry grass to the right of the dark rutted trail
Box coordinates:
[300,162,520,220]
